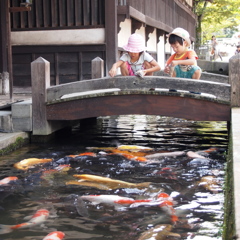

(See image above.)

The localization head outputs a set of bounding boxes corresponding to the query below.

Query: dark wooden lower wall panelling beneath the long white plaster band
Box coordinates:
[13,45,105,86]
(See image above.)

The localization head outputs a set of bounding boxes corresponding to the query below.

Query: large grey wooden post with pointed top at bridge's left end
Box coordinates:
[31,57,50,135]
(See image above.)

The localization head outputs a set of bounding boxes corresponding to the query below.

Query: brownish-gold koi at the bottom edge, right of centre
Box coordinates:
[138,224,181,240]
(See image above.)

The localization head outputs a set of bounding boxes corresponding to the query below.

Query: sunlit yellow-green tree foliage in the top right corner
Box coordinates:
[194,0,240,46]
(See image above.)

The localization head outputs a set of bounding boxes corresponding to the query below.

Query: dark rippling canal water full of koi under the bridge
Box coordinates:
[0,115,228,240]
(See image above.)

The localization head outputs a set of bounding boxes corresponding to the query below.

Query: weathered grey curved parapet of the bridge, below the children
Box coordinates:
[47,76,231,103]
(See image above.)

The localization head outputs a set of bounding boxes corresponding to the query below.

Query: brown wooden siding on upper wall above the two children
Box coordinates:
[118,0,196,37]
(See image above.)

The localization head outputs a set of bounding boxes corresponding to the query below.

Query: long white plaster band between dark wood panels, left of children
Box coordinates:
[11,28,105,45]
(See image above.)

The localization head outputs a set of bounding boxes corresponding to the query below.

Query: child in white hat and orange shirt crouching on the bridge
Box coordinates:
[164,28,202,79]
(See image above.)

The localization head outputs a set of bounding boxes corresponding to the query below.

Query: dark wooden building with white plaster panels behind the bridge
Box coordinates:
[0,0,196,86]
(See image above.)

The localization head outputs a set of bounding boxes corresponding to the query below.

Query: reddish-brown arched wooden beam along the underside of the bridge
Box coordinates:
[46,93,231,121]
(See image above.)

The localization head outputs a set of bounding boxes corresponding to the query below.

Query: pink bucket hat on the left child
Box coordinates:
[123,33,146,53]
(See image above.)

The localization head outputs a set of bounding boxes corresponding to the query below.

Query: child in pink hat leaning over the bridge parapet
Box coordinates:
[109,33,160,77]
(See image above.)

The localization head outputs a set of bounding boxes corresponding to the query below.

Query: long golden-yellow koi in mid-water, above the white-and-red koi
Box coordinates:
[70,174,151,189]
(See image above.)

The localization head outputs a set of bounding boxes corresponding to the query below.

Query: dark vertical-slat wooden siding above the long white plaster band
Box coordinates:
[10,0,105,31]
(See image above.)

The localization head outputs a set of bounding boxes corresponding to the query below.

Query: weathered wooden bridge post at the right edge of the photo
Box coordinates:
[229,54,240,107]
